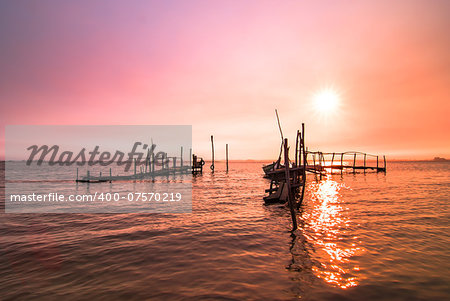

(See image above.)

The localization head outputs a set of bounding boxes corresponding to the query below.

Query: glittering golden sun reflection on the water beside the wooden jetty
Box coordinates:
[303,178,364,289]
